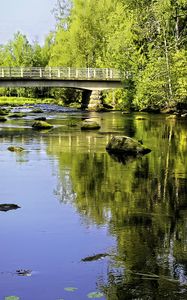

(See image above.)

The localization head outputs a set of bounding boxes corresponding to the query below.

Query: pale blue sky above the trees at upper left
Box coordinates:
[0,0,56,45]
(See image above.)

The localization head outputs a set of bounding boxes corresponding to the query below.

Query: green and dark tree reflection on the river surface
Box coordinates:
[2,113,187,300]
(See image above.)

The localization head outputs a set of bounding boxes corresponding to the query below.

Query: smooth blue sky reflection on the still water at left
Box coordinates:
[0,141,115,300]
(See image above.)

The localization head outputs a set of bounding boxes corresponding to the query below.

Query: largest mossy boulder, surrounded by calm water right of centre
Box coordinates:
[106,136,151,156]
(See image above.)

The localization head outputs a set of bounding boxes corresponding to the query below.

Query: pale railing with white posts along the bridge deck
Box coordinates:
[0,67,129,81]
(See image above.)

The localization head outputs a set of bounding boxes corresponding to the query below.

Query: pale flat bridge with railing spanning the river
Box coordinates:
[0,67,129,110]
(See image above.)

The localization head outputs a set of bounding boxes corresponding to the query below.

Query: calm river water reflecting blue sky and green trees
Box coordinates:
[0,107,187,300]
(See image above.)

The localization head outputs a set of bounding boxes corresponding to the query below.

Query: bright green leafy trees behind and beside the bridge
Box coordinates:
[0,0,187,109]
